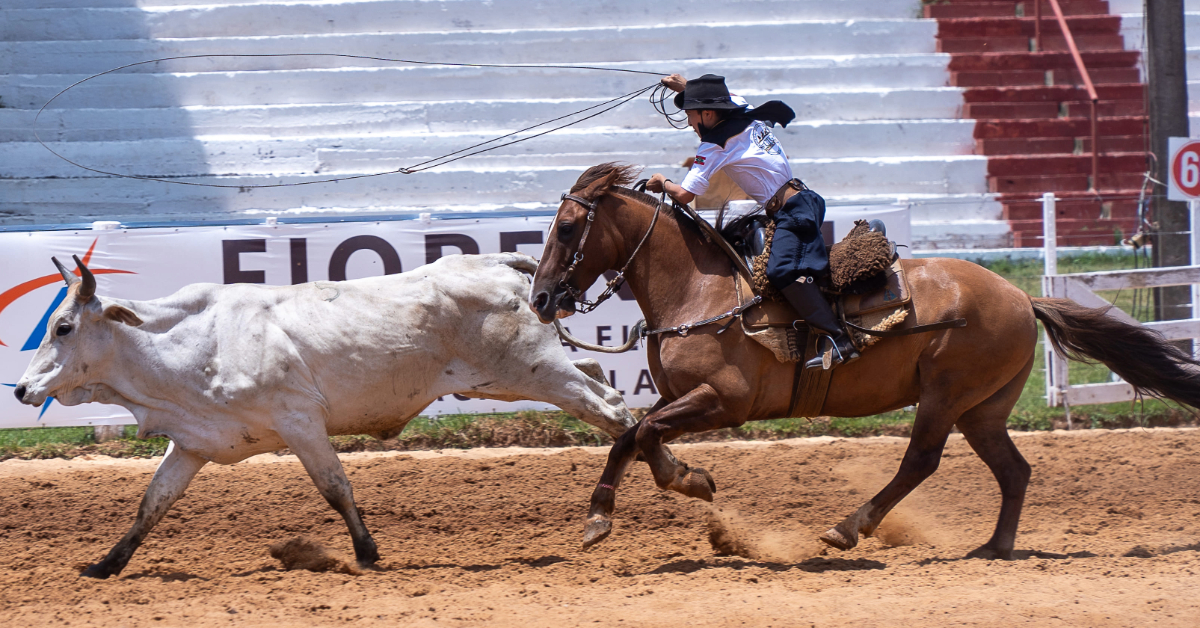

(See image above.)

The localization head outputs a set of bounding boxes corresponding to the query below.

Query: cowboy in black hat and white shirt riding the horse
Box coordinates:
[646,74,858,369]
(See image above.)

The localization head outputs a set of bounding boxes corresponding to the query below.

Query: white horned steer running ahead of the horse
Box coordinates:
[16,253,634,578]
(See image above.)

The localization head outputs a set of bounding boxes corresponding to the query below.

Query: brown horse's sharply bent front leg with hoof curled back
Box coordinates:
[637,384,729,502]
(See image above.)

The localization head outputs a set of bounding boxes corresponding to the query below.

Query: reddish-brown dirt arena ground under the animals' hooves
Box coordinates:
[0,430,1200,628]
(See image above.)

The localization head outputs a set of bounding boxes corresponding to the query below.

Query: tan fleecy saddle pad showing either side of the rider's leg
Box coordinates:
[736,259,914,363]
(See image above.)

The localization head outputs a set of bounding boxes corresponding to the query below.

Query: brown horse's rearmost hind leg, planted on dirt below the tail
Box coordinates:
[958,358,1033,560]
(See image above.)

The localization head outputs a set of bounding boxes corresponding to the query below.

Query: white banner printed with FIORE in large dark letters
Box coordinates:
[0,205,910,427]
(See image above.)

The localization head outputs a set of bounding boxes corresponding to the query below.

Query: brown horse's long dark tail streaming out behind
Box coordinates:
[1031,298,1200,408]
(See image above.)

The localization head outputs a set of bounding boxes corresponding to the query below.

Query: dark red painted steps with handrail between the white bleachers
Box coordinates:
[924,0,1147,246]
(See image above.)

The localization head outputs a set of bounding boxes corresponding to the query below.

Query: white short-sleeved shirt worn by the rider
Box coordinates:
[679,120,792,203]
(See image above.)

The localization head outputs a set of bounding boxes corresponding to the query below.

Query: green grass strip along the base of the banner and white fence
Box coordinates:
[7,248,1195,460]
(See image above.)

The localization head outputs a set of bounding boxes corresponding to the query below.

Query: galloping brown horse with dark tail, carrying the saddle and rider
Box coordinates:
[529,163,1200,558]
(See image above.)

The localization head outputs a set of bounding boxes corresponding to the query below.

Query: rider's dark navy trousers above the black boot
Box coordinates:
[767,190,829,289]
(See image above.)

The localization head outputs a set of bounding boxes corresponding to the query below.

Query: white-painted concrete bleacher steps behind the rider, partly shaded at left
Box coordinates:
[0,0,1009,249]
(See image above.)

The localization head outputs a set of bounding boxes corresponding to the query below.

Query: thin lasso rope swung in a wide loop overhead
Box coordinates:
[34,53,682,190]
